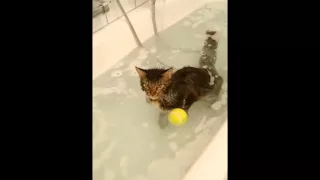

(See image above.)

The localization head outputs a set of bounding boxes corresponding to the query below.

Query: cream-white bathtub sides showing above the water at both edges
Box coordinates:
[92,0,227,180]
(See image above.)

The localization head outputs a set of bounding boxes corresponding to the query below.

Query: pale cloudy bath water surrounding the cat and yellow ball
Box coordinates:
[93,2,227,180]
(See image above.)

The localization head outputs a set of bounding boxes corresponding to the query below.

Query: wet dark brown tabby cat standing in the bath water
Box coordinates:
[136,31,223,128]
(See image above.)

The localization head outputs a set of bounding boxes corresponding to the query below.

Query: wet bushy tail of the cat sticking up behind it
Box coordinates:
[199,30,218,75]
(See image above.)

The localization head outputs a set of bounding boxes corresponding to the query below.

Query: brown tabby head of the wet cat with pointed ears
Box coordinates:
[136,67,173,100]
